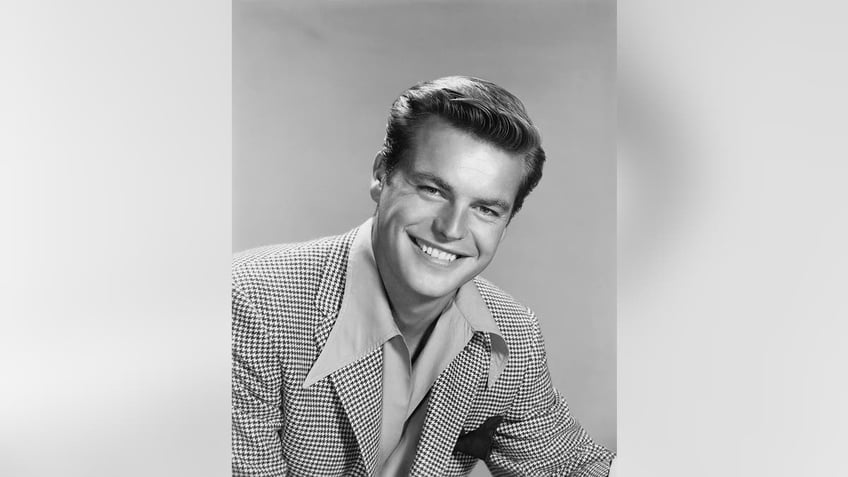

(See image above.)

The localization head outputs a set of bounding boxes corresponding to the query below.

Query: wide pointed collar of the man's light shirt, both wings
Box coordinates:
[303,218,509,388]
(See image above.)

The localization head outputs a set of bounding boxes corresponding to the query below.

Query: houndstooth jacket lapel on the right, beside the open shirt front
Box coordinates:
[410,333,489,476]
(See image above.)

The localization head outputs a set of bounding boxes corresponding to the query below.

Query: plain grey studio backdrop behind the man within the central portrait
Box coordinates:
[233,0,616,468]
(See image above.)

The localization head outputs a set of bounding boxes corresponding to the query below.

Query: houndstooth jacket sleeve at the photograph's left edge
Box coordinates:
[232,283,286,476]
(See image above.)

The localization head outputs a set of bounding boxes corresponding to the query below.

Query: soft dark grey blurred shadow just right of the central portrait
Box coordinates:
[617,52,702,293]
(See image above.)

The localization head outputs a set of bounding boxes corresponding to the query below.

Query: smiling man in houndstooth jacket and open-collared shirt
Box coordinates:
[233,77,613,476]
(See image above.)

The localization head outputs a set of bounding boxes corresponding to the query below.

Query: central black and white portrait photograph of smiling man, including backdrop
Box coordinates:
[232,1,616,476]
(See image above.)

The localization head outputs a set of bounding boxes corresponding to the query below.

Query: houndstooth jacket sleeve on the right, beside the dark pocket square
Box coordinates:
[486,313,614,477]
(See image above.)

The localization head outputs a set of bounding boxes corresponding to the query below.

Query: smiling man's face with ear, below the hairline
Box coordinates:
[371,118,524,305]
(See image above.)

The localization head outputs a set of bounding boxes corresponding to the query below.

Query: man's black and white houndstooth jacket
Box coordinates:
[232,230,613,477]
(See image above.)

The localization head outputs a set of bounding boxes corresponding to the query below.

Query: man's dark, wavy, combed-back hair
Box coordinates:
[379,76,545,215]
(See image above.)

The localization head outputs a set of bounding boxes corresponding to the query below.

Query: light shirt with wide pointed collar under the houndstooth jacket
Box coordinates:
[303,219,509,476]
